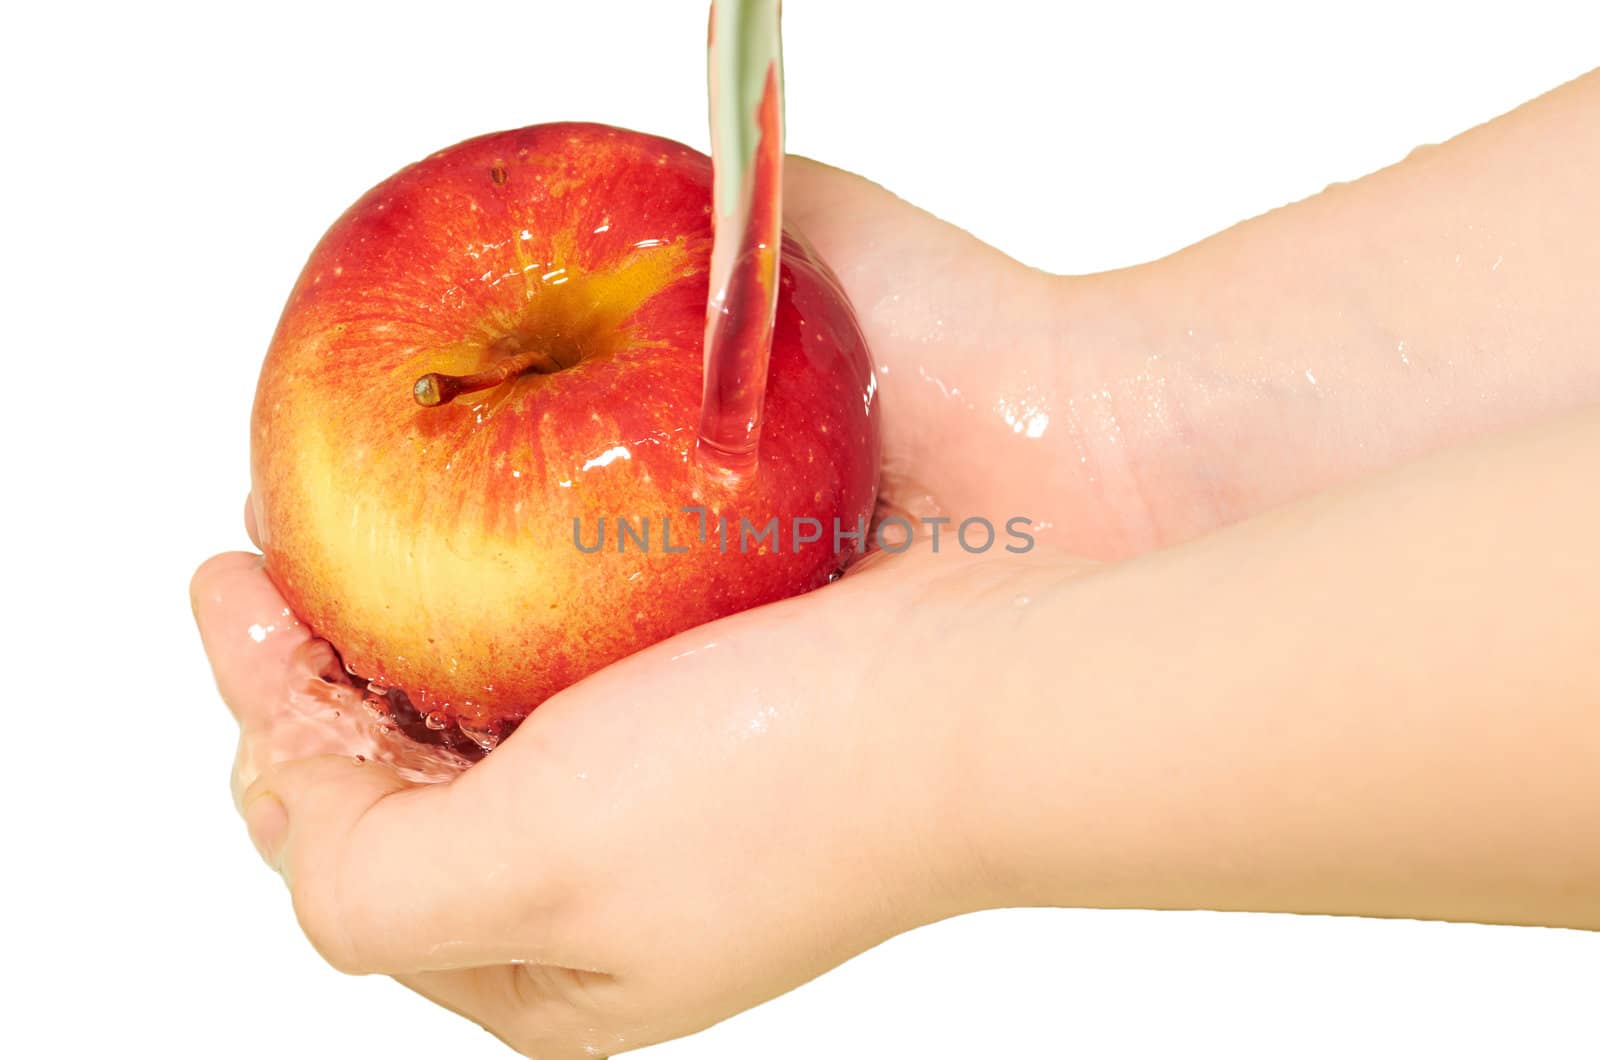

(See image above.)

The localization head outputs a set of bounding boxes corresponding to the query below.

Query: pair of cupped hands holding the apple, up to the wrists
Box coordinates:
[192,160,1122,1057]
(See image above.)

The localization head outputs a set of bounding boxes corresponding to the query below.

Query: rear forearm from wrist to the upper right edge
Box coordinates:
[1081,72,1600,551]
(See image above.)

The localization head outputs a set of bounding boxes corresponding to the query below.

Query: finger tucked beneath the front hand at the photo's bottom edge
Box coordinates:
[395,964,620,1060]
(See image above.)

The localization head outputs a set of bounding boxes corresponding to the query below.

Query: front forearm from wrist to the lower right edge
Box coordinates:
[966,406,1600,927]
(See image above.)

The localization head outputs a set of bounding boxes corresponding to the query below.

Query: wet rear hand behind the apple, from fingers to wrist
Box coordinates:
[784,159,1171,559]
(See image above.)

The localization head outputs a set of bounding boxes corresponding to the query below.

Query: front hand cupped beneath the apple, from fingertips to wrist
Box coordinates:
[194,534,1069,1057]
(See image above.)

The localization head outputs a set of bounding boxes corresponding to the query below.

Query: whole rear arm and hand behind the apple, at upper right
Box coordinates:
[789,72,1600,557]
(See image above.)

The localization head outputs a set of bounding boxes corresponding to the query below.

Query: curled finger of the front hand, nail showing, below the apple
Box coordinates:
[242,754,560,974]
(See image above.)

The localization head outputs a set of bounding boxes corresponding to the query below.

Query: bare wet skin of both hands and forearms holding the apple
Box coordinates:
[194,75,1600,1057]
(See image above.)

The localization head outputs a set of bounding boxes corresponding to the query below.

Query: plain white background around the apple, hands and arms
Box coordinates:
[0,0,1600,1060]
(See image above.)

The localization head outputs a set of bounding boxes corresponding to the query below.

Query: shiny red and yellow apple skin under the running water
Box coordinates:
[251,123,880,740]
